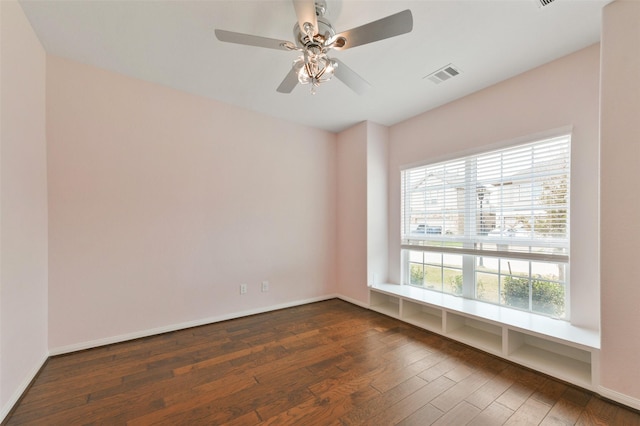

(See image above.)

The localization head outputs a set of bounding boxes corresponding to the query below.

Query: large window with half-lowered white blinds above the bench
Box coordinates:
[401,135,571,319]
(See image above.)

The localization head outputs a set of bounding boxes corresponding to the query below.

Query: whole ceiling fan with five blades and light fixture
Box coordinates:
[215,0,413,94]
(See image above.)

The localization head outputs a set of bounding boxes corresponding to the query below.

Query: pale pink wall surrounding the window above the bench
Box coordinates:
[389,45,600,329]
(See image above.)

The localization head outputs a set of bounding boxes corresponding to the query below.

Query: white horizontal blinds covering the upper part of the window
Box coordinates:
[402,135,571,262]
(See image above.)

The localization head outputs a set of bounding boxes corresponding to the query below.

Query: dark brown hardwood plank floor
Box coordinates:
[5,299,640,426]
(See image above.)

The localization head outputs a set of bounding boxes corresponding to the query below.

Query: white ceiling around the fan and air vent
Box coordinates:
[21,0,611,132]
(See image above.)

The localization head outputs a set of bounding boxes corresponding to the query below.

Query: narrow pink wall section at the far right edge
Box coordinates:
[600,0,640,402]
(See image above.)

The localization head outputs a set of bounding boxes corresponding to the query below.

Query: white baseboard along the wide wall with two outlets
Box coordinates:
[49,294,336,356]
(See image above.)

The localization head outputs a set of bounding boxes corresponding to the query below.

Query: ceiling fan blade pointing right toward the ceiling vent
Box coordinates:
[335,9,413,50]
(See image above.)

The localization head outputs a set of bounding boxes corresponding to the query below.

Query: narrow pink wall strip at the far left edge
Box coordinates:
[0,1,48,420]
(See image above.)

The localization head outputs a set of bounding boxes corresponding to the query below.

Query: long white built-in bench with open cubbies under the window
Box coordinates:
[369,284,600,390]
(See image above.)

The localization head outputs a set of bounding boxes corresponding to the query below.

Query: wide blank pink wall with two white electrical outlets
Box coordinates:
[47,56,337,351]
